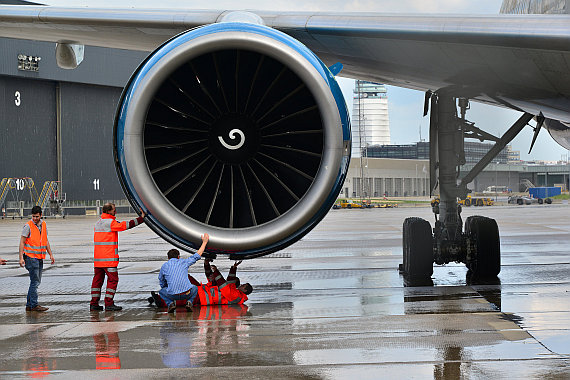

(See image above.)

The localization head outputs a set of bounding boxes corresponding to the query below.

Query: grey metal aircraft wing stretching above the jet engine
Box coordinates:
[0,6,570,116]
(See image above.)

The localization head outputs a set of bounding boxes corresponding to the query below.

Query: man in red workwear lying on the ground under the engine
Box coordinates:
[148,260,253,307]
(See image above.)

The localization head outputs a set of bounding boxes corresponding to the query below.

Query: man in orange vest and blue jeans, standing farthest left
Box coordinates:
[19,206,55,311]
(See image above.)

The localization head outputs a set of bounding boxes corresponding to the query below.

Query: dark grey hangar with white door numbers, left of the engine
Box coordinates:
[0,39,146,214]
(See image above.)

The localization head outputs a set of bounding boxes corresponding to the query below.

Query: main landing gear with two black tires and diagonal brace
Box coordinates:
[400,91,542,283]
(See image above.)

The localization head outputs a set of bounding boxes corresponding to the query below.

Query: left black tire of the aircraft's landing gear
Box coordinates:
[403,217,433,278]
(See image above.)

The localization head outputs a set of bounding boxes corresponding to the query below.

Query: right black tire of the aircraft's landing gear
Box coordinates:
[465,216,501,278]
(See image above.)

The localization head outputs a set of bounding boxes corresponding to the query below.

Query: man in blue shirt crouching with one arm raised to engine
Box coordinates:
[158,234,210,313]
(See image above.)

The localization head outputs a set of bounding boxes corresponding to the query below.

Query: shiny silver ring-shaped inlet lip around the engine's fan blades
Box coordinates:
[123,23,343,252]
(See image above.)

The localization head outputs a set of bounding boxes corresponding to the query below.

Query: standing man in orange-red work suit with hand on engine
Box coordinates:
[89,203,145,311]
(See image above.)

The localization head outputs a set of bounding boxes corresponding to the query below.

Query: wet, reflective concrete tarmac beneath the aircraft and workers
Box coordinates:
[0,205,570,380]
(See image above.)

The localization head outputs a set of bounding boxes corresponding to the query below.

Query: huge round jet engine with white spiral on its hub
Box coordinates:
[114,23,350,259]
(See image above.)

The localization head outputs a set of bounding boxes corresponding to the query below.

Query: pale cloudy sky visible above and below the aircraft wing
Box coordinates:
[43,0,569,161]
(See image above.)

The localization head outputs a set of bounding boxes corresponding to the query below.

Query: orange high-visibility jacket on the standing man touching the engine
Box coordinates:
[93,213,128,268]
